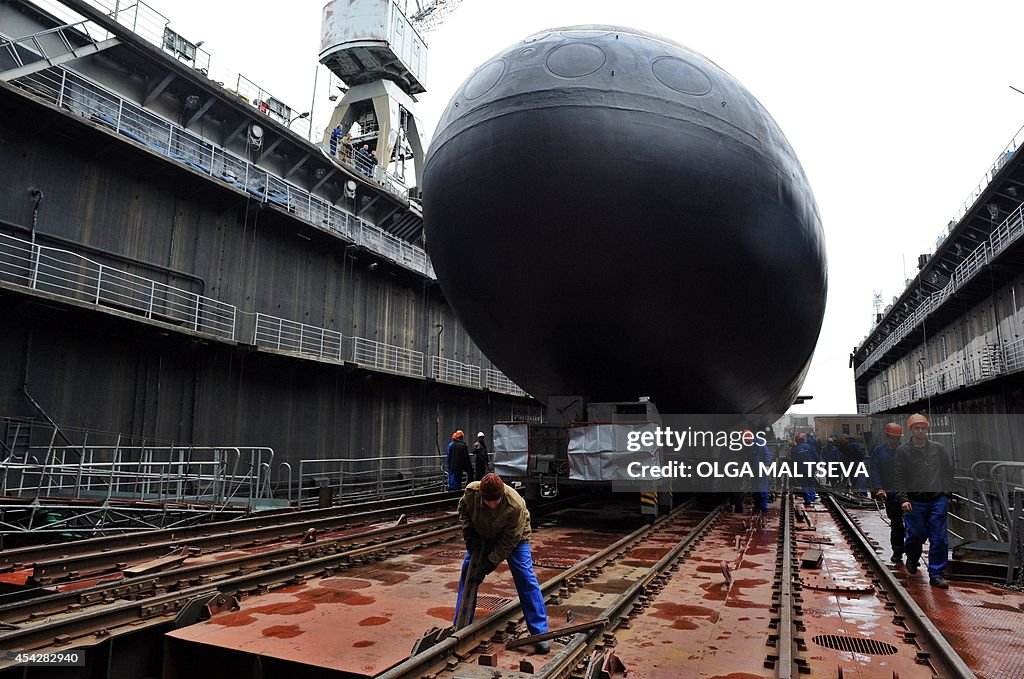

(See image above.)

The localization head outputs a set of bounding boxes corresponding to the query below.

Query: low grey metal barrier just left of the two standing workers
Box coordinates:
[297,455,446,508]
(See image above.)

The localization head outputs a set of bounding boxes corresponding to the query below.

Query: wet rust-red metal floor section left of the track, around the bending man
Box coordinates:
[161,510,629,677]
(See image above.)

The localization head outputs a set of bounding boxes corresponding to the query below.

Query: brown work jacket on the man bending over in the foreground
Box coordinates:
[459,481,532,566]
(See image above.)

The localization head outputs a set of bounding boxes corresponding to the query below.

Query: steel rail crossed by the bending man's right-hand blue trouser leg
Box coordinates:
[376,501,693,679]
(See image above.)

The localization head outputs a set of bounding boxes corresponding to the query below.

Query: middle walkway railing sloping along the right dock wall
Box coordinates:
[854,205,1024,378]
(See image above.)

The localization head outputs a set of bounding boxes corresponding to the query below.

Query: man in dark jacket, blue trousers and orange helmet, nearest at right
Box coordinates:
[893,413,953,589]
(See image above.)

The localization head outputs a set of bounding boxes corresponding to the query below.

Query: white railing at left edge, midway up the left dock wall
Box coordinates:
[0,234,236,340]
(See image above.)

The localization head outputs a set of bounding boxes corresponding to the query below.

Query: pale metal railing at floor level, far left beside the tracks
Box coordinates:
[0,444,273,506]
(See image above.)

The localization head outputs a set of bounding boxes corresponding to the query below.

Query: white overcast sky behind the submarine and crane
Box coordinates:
[159,0,1024,413]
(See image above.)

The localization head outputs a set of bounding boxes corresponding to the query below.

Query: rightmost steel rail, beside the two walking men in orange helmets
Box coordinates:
[825,497,975,679]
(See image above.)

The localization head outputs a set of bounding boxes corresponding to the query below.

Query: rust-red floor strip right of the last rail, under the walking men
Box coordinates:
[850,509,1024,679]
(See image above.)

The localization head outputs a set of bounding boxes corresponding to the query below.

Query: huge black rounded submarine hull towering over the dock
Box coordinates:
[422,25,827,415]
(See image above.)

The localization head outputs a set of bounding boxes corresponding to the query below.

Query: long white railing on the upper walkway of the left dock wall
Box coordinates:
[13,67,423,280]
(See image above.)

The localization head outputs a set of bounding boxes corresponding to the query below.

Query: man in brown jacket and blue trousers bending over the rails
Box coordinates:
[456,473,551,655]
